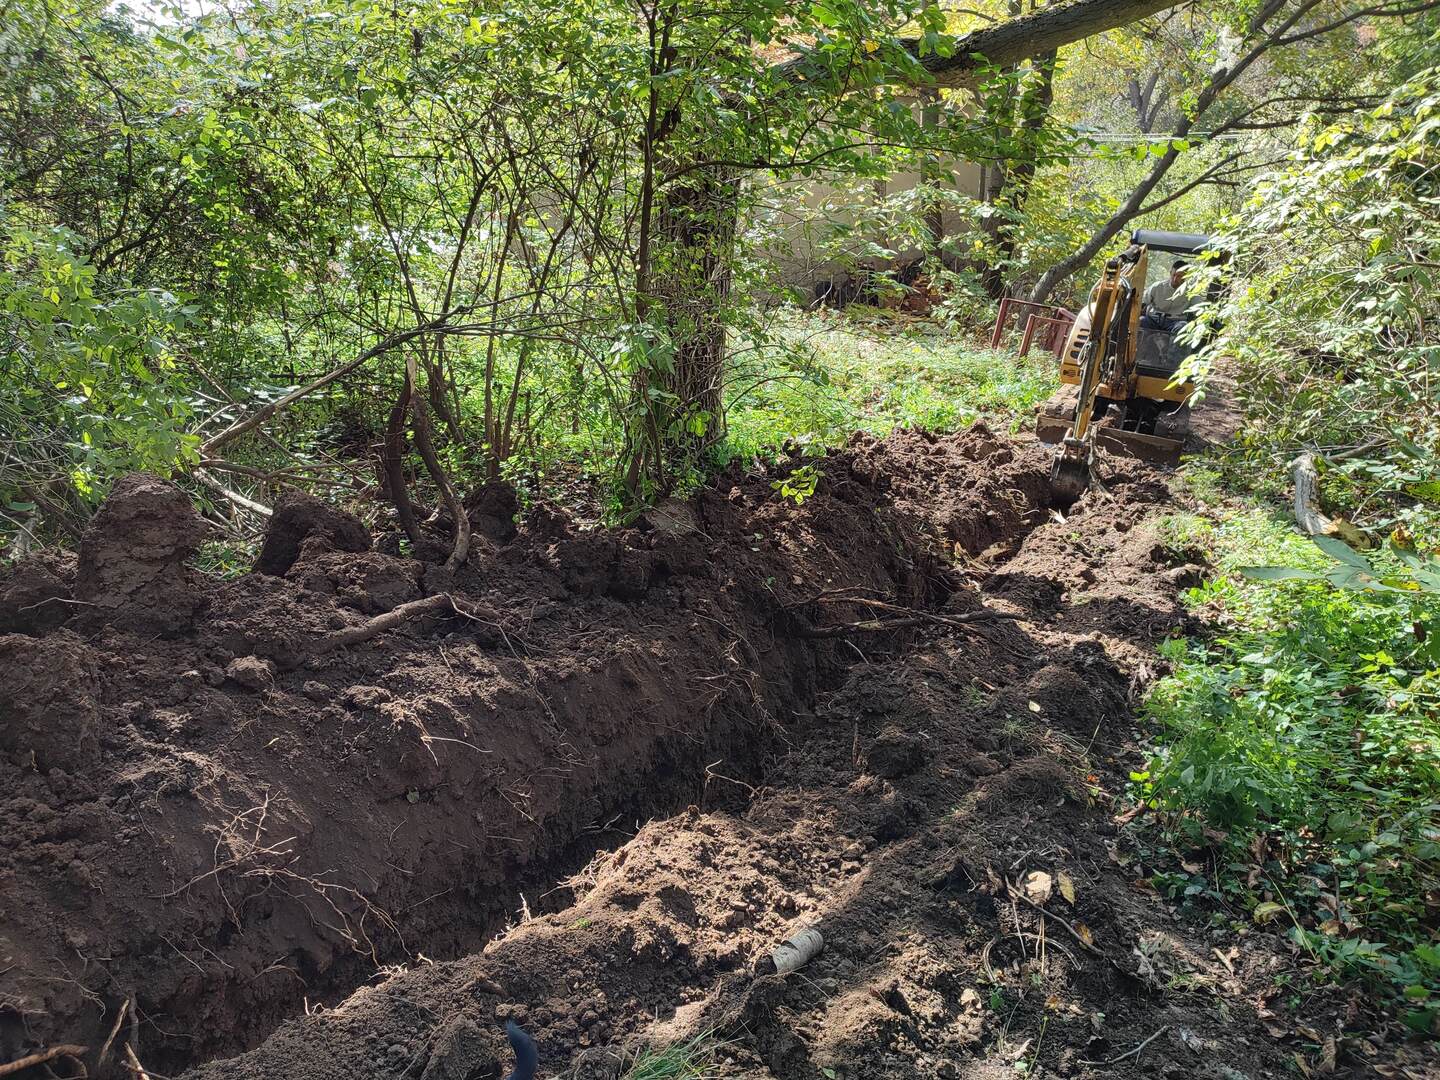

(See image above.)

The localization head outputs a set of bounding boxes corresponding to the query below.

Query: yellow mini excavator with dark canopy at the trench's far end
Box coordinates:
[1035,229,1211,510]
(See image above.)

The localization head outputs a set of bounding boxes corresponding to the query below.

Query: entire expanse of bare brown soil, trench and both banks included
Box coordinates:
[0,428,1428,1080]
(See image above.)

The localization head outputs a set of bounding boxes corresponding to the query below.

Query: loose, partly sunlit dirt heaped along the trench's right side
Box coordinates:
[180,455,1307,1080]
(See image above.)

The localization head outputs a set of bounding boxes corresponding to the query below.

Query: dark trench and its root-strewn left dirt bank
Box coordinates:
[0,426,1047,1076]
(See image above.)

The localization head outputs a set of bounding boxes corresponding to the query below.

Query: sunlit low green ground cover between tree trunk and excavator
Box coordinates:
[727,308,1058,456]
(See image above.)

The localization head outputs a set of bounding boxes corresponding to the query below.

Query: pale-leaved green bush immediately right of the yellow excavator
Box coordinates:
[1195,55,1440,530]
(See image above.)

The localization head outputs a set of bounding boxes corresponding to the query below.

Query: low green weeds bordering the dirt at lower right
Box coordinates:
[1132,503,1440,1031]
